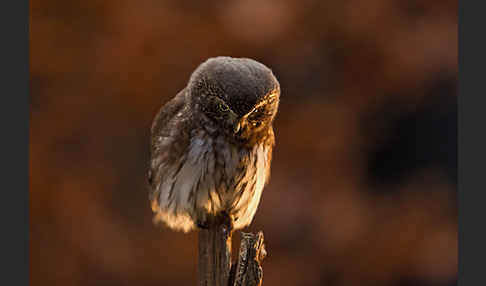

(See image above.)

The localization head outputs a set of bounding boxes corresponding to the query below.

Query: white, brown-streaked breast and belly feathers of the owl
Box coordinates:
[155,133,268,232]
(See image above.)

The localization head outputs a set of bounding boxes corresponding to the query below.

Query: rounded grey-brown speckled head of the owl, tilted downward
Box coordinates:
[188,57,280,144]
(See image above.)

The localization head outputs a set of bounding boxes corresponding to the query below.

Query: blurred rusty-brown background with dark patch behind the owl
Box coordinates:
[30,0,458,286]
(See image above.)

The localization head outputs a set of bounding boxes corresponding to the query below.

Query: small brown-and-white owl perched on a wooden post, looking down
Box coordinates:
[148,57,280,232]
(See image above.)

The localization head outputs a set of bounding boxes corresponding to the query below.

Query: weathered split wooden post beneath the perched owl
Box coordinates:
[198,214,266,286]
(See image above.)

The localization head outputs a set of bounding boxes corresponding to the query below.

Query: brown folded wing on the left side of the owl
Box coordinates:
[147,89,191,204]
